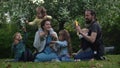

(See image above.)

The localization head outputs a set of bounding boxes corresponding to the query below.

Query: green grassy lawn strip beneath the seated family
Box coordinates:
[0,55,120,68]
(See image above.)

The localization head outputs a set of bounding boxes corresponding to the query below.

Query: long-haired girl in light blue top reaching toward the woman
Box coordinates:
[51,30,72,61]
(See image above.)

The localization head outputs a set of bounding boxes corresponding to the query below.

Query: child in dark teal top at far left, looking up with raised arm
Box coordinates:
[12,29,32,62]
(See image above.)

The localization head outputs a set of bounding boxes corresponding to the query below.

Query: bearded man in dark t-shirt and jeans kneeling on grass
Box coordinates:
[75,10,104,60]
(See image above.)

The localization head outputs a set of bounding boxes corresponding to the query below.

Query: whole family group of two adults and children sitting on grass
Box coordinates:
[12,7,105,62]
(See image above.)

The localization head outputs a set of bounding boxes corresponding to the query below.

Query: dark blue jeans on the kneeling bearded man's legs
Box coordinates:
[74,48,94,60]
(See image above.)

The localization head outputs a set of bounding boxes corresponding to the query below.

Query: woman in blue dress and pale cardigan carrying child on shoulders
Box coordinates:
[34,19,58,62]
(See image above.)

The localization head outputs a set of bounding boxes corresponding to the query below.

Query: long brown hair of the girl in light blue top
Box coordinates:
[59,30,72,56]
